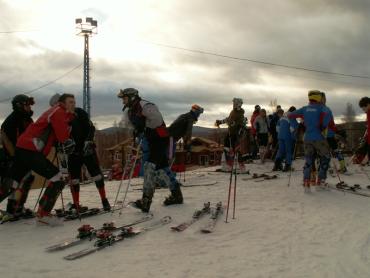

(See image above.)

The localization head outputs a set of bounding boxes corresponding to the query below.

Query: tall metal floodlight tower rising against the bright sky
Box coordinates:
[75,17,98,118]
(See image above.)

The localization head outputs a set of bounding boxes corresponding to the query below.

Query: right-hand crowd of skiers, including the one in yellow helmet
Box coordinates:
[215,90,370,192]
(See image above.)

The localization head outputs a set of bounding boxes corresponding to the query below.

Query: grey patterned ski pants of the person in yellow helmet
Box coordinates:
[303,140,330,181]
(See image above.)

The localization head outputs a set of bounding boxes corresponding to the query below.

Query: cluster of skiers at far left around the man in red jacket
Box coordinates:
[0,94,110,224]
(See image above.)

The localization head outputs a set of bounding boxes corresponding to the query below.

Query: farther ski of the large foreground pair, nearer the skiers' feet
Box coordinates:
[45,214,153,252]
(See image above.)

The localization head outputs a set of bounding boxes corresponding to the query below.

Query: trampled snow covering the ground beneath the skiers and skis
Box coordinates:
[0,160,370,278]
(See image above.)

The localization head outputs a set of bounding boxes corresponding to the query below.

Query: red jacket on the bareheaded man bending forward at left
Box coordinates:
[17,104,73,155]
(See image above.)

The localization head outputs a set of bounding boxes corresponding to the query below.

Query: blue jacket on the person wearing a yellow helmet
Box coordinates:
[288,102,330,141]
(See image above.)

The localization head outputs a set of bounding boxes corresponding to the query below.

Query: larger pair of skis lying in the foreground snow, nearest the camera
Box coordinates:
[46,214,172,260]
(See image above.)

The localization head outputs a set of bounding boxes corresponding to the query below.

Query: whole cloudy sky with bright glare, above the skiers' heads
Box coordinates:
[0,0,370,128]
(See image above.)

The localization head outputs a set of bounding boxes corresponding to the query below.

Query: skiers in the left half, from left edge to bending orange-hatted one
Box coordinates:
[0,88,203,225]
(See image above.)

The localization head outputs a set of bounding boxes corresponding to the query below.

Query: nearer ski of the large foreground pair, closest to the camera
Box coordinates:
[64,216,172,261]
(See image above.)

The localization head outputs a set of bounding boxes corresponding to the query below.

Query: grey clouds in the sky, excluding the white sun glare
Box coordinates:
[0,0,370,128]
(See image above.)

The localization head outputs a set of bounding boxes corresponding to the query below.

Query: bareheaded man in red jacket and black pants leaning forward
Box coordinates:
[11,94,75,225]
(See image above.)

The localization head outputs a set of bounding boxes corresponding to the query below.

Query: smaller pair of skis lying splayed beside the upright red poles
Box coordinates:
[171,202,223,233]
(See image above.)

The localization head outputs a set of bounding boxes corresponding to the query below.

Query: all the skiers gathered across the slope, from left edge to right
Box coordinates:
[0,88,370,224]
